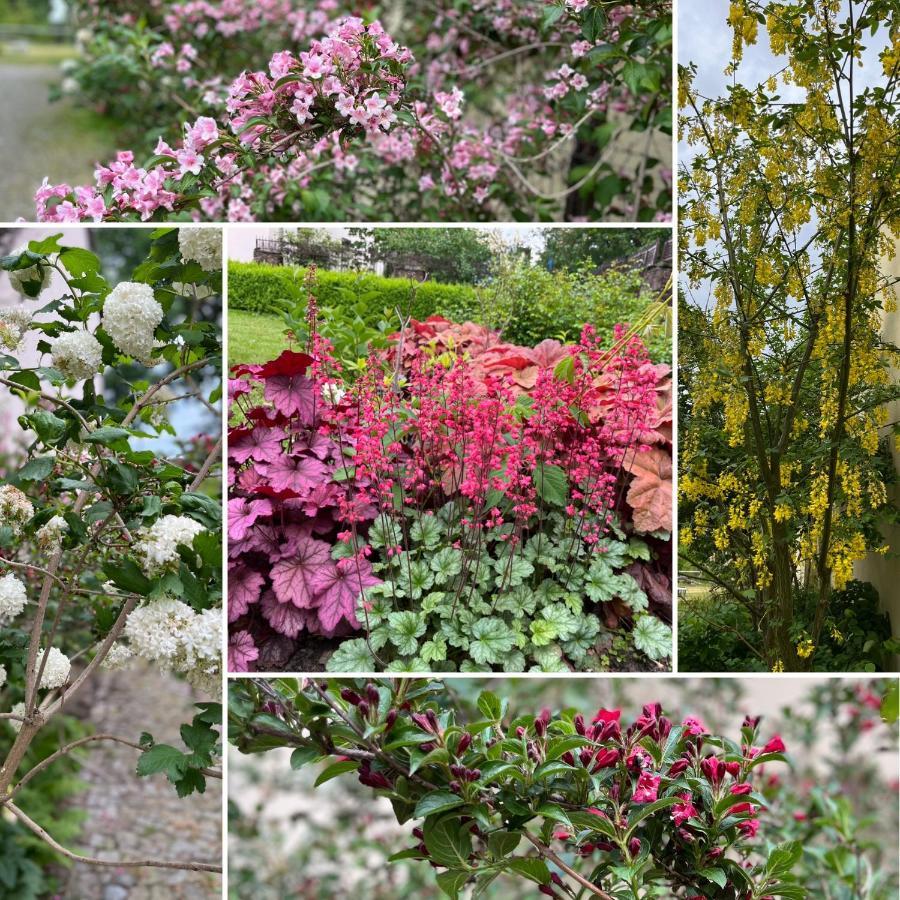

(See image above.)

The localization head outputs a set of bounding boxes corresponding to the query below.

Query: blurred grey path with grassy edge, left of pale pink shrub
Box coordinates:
[0,64,113,222]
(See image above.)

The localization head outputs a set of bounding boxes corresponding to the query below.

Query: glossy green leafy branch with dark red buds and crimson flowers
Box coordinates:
[229,679,807,900]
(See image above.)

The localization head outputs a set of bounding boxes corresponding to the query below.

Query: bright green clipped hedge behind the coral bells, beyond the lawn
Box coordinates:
[228,262,479,328]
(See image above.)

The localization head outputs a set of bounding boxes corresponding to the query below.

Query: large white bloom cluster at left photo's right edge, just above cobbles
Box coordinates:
[125,597,222,694]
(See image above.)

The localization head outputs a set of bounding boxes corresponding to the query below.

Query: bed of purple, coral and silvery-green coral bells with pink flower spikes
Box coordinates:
[229,298,671,671]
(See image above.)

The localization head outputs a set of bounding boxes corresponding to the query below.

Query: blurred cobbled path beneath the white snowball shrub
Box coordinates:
[61,667,222,900]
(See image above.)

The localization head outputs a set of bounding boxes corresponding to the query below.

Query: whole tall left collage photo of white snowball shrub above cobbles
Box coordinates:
[0,227,223,898]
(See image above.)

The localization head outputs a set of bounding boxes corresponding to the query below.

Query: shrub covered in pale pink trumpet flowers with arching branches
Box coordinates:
[44,0,671,221]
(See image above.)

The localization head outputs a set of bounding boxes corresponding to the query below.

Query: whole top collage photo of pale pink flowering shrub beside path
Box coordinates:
[0,0,673,222]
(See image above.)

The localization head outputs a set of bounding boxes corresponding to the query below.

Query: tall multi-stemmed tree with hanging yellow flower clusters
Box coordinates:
[679,0,900,671]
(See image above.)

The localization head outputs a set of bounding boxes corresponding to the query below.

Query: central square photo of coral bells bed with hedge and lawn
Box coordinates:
[228,227,672,673]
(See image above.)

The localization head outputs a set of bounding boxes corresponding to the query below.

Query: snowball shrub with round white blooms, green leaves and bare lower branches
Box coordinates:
[0,229,221,871]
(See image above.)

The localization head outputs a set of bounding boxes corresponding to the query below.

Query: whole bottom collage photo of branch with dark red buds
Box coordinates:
[228,676,900,900]
